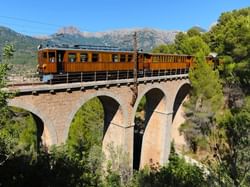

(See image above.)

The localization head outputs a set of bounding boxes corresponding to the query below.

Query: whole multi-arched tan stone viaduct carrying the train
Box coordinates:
[9,74,190,167]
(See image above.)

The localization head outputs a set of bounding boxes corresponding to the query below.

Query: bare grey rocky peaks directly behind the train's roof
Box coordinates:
[51,26,178,51]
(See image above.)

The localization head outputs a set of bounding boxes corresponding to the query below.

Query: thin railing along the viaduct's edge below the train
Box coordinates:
[6,68,189,85]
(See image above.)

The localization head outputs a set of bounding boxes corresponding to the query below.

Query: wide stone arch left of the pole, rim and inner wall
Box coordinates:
[63,91,128,152]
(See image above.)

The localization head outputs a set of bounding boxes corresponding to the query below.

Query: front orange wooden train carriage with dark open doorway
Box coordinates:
[38,48,139,74]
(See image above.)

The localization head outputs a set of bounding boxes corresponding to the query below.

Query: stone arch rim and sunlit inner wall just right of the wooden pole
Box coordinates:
[132,86,167,168]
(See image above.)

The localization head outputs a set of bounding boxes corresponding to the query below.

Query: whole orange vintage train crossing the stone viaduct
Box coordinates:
[37,45,218,82]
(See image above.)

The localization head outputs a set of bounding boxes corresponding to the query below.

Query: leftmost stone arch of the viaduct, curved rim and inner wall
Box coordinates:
[8,99,58,147]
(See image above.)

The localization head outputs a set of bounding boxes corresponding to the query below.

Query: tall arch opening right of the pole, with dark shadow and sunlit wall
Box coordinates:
[133,88,166,170]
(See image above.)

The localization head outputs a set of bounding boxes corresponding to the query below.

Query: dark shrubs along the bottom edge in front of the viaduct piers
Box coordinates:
[0,146,214,187]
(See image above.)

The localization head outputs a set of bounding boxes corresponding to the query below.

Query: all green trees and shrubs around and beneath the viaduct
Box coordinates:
[0,8,250,187]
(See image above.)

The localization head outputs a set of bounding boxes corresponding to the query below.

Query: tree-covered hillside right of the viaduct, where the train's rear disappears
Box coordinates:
[155,8,250,186]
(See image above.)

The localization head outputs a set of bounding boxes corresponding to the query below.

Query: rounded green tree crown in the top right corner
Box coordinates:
[207,8,250,63]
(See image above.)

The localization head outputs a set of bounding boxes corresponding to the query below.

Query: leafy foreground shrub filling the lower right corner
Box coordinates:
[213,97,250,186]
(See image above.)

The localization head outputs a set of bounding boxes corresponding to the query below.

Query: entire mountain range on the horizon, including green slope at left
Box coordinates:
[0,26,179,70]
